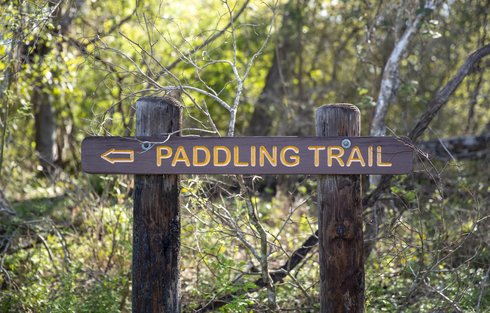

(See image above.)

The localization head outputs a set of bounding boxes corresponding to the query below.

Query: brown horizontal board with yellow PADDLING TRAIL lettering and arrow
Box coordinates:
[82,136,413,175]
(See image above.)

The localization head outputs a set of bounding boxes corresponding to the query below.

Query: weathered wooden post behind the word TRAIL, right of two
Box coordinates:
[316,103,364,313]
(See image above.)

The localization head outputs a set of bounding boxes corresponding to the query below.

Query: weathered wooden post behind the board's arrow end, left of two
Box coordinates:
[132,97,182,313]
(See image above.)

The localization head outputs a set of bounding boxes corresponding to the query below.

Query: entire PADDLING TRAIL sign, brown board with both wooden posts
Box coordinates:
[82,97,413,313]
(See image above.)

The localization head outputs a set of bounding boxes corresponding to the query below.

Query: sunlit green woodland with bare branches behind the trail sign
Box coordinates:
[0,0,490,312]
